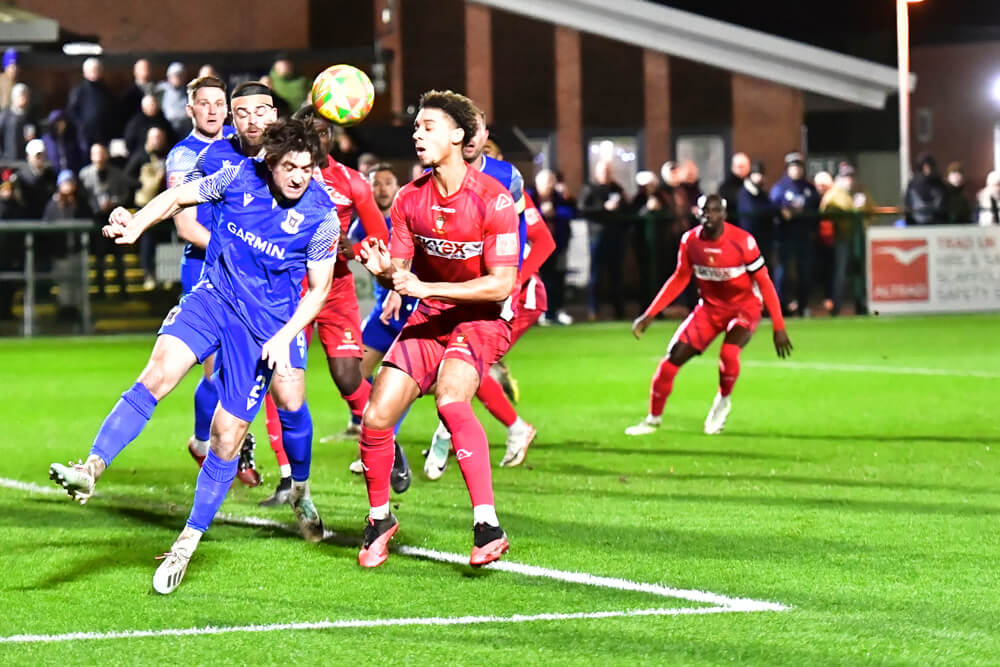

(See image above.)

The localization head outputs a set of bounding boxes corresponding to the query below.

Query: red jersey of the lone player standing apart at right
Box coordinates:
[677,223,764,308]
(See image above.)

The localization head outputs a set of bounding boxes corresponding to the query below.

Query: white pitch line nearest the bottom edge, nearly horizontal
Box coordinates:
[0,607,743,644]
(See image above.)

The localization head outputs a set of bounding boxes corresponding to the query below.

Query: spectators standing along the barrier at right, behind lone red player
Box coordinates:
[569,145,1000,319]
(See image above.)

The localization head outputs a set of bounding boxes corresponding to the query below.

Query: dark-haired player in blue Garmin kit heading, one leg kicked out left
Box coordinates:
[49,120,340,594]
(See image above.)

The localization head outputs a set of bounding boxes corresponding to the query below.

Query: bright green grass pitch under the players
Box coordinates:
[0,315,1000,665]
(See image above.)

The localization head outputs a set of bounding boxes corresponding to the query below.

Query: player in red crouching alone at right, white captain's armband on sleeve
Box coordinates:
[625,195,792,435]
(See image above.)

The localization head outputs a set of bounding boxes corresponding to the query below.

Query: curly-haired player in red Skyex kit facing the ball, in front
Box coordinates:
[358,90,520,567]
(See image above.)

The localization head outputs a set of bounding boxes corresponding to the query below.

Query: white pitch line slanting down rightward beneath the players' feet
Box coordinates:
[0,477,790,612]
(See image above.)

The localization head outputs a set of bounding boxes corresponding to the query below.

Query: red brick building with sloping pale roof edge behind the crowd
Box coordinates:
[11,0,895,193]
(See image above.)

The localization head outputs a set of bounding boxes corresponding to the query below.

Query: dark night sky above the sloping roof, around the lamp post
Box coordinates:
[653,0,1000,63]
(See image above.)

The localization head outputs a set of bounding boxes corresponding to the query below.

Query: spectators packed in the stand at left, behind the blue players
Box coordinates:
[0,49,318,318]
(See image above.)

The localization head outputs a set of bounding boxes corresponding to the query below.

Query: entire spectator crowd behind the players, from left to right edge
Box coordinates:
[0,49,1000,324]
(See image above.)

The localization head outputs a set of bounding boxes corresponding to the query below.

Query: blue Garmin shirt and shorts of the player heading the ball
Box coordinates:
[160,160,340,421]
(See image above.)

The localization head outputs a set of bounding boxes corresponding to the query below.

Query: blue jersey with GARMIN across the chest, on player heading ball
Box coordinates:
[198,160,340,342]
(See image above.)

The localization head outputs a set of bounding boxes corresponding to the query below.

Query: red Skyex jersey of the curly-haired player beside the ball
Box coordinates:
[389,168,520,319]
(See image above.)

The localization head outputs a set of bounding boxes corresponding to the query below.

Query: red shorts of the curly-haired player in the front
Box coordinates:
[382,309,511,395]
